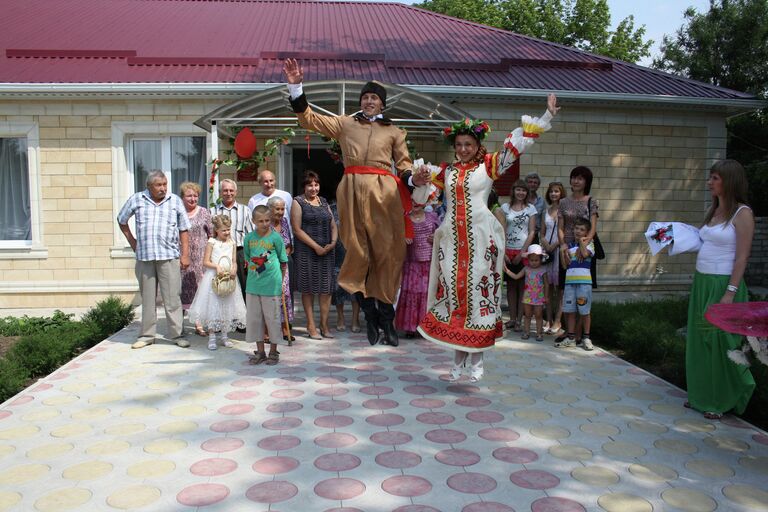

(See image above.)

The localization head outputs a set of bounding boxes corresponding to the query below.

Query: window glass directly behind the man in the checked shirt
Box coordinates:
[129,136,208,202]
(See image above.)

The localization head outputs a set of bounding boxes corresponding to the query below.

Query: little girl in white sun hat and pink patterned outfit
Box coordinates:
[504,244,549,342]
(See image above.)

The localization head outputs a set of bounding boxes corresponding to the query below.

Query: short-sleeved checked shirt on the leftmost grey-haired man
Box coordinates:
[117,190,190,261]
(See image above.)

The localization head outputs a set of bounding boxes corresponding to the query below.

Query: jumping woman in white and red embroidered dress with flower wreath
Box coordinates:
[418,94,558,382]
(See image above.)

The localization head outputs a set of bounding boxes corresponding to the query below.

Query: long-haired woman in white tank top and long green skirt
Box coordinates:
[685,160,755,419]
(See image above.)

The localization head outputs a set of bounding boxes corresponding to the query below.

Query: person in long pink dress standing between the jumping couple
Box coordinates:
[395,203,440,338]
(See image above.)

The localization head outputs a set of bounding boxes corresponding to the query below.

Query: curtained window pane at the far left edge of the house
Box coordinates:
[0,137,32,245]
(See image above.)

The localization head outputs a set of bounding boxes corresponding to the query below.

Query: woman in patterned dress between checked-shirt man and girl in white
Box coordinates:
[179,181,213,336]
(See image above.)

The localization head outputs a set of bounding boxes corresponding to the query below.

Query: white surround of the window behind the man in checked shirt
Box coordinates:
[110,121,211,259]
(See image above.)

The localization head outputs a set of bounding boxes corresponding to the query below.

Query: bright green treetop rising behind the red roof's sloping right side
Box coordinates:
[417,0,653,62]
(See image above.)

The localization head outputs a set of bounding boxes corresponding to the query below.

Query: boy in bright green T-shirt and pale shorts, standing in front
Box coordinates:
[243,205,288,365]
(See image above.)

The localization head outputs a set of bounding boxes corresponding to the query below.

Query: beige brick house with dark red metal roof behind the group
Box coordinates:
[0,0,763,308]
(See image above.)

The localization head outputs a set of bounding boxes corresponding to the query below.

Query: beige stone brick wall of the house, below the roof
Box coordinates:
[0,96,725,308]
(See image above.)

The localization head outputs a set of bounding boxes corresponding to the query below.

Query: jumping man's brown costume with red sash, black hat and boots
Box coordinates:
[291,82,412,344]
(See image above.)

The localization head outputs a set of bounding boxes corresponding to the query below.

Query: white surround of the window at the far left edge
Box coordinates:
[0,121,48,259]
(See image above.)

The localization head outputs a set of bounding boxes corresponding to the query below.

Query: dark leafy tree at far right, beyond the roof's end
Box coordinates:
[653,0,768,215]
